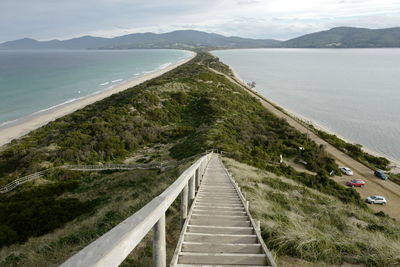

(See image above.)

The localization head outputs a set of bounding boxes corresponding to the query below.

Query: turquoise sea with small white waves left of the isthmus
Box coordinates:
[0,50,189,127]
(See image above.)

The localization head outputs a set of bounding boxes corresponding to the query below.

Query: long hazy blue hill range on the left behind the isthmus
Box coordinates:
[0,30,280,49]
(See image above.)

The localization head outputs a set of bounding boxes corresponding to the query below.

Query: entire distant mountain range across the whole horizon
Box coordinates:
[0,27,400,49]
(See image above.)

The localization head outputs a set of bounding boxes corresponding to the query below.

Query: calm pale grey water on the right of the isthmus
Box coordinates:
[213,49,400,162]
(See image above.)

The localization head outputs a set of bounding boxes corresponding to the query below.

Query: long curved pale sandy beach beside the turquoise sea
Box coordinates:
[0,51,196,146]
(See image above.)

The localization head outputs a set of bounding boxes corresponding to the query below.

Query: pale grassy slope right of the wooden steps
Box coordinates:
[224,158,400,266]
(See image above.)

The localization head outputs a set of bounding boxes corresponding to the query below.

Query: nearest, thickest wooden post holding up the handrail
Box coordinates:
[153,214,167,267]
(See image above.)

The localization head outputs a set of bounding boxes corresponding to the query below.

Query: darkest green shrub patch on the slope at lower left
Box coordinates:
[0,180,96,247]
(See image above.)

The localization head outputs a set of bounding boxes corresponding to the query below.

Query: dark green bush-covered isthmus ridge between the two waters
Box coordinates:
[0,53,336,184]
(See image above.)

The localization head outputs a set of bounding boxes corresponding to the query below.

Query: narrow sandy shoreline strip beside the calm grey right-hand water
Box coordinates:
[231,69,400,174]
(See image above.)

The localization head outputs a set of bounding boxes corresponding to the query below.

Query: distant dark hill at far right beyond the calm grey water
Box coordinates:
[281,27,400,48]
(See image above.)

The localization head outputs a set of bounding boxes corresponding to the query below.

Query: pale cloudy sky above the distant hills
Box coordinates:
[0,0,400,42]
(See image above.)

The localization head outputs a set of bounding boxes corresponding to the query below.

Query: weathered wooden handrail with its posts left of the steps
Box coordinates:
[61,152,212,267]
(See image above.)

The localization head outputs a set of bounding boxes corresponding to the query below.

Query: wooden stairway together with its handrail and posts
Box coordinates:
[61,152,276,267]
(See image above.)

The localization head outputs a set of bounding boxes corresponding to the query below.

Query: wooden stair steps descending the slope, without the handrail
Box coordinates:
[171,154,276,267]
